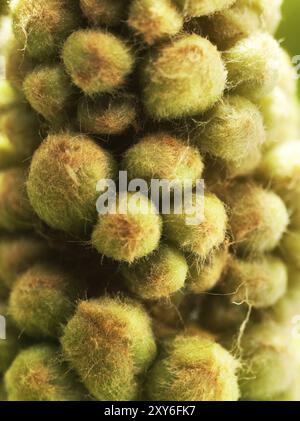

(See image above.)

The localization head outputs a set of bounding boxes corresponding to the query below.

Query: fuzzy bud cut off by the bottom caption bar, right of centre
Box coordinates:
[146,335,239,401]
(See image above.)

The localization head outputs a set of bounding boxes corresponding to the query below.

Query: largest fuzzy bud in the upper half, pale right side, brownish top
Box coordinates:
[142,35,227,120]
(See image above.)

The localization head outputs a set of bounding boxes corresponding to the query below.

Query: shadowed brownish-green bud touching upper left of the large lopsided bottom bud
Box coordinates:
[9,263,83,339]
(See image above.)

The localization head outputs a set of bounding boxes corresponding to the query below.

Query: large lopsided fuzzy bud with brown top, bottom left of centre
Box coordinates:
[61,298,156,401]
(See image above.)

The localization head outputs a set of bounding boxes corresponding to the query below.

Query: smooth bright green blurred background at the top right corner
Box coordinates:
[277,0,300,94]
